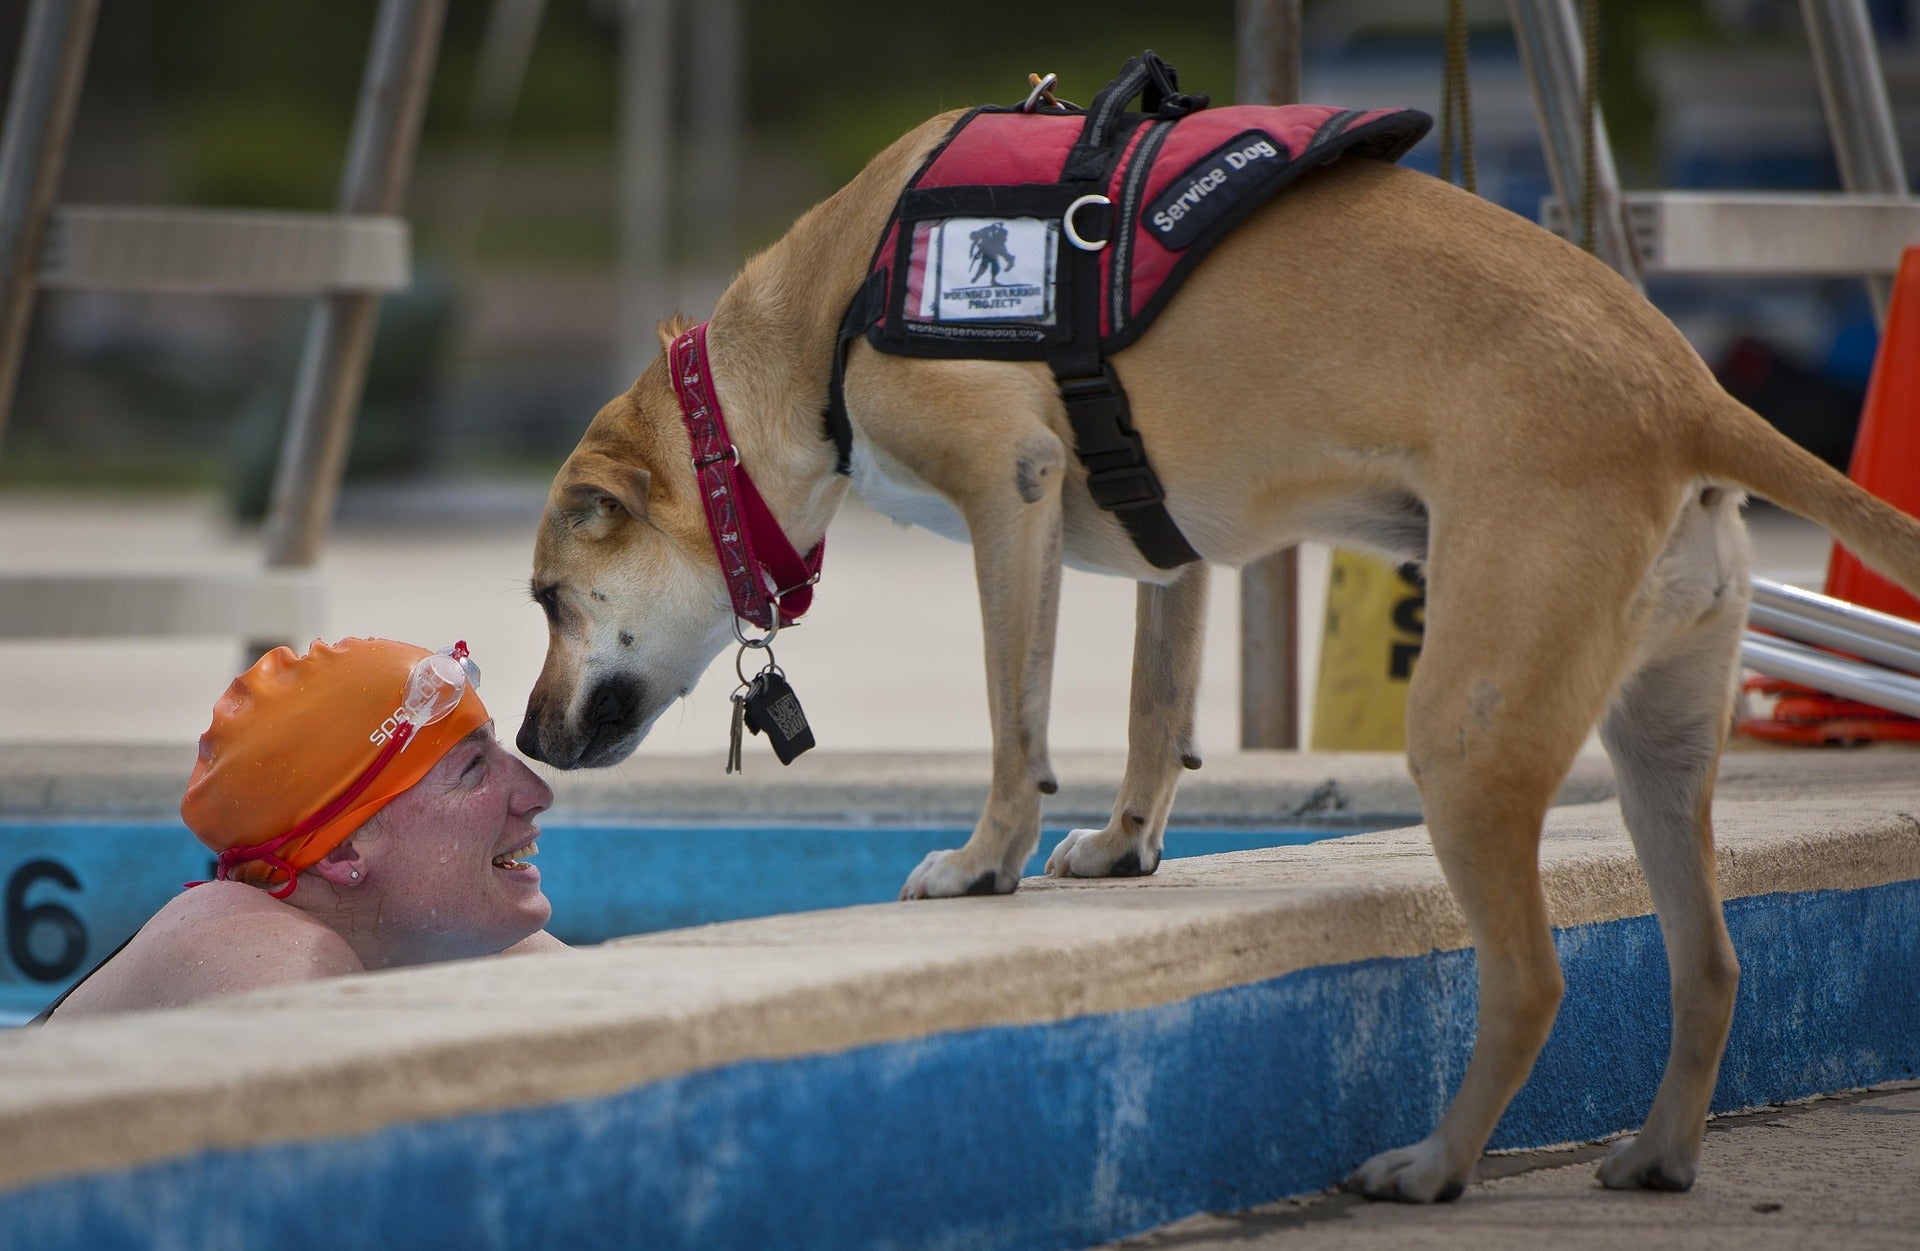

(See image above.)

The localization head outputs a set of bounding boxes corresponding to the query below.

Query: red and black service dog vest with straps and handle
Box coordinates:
[828,52,1432,568]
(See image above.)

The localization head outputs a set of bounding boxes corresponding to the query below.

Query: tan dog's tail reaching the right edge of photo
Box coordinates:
[1697,391,1920,595]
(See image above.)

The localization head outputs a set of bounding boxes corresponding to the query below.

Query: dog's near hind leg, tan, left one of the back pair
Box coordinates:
[1348,485,1659,1203]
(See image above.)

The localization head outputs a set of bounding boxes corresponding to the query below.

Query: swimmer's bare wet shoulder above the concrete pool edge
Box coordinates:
[56,883,363,1021]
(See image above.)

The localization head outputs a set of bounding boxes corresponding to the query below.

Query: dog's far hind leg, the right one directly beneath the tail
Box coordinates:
[1599,501,1747,1190]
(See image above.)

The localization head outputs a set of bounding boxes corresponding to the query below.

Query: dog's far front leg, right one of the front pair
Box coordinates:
[1046,562,1208,877]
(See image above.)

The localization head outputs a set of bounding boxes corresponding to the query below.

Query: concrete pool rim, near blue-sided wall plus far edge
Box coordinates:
[0,748,1920,1247]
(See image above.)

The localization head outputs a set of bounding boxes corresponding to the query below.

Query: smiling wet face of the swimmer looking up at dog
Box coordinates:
[349,721,553,967]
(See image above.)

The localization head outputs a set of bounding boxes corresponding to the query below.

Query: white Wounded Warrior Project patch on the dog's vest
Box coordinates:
[908,217,1060,326]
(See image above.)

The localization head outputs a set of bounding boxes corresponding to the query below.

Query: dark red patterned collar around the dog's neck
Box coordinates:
[666,322,828,629]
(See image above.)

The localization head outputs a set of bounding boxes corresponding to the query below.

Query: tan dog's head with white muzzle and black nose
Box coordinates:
[518,320,733,769]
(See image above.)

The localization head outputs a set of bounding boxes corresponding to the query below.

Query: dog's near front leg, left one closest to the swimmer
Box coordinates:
[900,430,1066,900]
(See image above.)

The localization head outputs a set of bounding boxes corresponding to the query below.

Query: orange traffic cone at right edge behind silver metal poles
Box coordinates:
[1740,246,1920,743]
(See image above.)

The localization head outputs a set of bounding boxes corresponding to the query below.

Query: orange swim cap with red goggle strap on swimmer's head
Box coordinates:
[180,639,488,894]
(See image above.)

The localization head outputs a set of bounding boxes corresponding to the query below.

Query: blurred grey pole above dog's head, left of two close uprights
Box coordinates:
[614,0,674,391]
